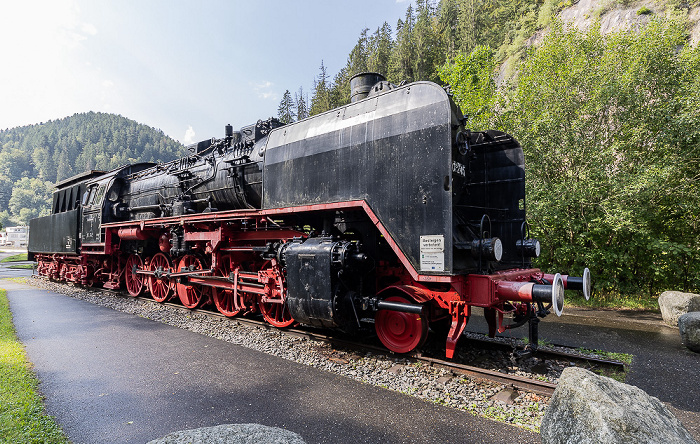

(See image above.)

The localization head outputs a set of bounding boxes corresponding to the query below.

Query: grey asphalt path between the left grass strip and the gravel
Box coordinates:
[5,281,539,444]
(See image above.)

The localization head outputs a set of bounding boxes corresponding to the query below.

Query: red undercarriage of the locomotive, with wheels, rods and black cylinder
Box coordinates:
[35,202,590,358]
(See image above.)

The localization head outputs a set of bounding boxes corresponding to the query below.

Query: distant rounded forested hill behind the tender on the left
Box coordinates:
[0,112,184,226]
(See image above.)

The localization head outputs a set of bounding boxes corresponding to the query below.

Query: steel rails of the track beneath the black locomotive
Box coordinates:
[108,290,624,397]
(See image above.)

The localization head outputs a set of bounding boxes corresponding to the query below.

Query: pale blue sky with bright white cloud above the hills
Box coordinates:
[0,0,409,144]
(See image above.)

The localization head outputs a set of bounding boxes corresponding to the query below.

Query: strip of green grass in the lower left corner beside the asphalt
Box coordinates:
[0,290,69,443]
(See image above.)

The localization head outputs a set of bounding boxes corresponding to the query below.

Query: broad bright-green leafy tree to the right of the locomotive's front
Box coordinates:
[493,18,700,297]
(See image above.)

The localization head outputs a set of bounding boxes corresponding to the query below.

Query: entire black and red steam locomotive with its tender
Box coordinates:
[29,73,590,358]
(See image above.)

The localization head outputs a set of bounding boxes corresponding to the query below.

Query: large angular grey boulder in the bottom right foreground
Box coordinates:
[540,367,698,444]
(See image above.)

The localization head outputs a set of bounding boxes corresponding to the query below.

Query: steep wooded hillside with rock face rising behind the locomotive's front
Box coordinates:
[280,0,700,300]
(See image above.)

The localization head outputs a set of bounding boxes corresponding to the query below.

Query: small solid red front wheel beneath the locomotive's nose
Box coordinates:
[374,296,428,353]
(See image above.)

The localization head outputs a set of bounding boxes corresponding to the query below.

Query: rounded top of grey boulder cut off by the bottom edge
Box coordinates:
[148,424,304,444]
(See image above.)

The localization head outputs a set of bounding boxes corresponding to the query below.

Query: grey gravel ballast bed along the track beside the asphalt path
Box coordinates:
[28,278,556,431]
